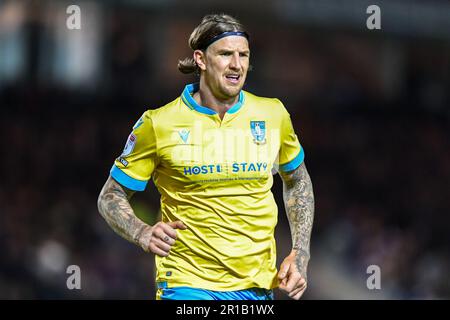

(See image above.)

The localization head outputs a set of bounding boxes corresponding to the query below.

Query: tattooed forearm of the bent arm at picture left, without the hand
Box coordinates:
[97,177,150,244]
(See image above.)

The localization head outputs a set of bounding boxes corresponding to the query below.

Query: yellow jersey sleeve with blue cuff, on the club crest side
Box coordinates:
[278,102,305,172]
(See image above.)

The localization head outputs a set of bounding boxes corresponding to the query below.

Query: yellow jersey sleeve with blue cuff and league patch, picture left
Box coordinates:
[110,110,158,191]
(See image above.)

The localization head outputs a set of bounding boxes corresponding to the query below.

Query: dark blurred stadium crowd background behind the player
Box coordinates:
[0,0,450,299]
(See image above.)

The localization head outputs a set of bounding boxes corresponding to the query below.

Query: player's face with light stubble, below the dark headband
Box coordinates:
[201,36,250,100]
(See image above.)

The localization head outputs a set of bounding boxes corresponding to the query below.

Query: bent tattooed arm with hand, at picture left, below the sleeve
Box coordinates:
[97,177,186,257]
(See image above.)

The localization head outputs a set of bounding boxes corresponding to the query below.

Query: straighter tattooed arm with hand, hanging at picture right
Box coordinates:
[278,162,314,300]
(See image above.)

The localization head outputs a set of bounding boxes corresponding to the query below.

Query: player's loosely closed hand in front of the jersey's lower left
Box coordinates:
[139,221,186,257]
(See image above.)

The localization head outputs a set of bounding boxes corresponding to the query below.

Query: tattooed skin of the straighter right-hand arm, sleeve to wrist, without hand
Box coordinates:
[281,163,314,279]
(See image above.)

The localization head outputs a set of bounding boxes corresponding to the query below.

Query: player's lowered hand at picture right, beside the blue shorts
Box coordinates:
[278,250,307,300]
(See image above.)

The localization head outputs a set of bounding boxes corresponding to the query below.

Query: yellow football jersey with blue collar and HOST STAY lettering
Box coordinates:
[111,84,304,291]
